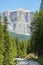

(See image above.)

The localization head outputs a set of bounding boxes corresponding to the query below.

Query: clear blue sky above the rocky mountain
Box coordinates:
[0,0,41,12]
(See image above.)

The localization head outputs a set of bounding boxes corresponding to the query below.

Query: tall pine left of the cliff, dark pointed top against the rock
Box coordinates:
[3,17,12,65]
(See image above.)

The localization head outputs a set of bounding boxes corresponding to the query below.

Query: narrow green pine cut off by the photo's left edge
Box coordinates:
[0,16,4,65]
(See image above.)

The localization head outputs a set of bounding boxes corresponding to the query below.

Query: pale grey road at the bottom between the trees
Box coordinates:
[16,59,40,65]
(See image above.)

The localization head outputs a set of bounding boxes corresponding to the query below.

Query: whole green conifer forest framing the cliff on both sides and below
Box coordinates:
[0,0,43,65]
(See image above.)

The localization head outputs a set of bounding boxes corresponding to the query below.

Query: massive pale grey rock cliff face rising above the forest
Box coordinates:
[2,9,33,35]
